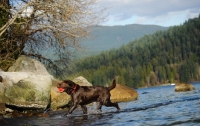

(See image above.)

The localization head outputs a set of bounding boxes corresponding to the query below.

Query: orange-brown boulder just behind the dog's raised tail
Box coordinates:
[110,84,138,102]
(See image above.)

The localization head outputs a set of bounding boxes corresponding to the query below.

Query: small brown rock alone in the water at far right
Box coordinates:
[175,83,195,92]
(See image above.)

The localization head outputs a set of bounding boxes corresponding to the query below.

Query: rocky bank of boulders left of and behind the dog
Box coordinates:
[0,56,138,118]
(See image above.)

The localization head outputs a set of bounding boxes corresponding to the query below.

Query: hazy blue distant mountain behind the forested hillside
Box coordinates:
[79,24,168,57]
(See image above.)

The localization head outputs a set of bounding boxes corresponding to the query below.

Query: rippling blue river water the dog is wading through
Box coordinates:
[0,83,200,126]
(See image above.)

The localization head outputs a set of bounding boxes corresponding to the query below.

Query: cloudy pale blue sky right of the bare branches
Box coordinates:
[98,0,200,27]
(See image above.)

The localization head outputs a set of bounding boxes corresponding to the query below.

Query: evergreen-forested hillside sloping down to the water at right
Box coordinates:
[68,16,200,88]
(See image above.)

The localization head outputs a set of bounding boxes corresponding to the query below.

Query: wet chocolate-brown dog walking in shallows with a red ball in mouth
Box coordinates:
[57,80,120,115]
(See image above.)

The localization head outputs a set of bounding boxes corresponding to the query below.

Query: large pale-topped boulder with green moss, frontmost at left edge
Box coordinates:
[0,72,52,108]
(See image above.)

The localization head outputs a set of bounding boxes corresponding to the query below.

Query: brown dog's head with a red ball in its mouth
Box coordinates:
[57,80,77,95]
